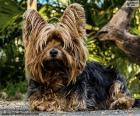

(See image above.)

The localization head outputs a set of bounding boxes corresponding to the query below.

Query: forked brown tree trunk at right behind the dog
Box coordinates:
[96,1,140,64]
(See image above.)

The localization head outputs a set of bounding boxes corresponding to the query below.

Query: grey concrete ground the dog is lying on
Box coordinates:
[0,101,140,116]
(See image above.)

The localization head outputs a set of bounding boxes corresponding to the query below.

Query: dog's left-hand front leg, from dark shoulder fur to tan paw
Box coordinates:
[28,80,65,111]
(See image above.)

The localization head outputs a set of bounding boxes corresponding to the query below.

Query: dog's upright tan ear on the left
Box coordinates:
[23,9,47,46]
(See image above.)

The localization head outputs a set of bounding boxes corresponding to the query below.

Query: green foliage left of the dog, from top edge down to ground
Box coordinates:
[0,0,26,99]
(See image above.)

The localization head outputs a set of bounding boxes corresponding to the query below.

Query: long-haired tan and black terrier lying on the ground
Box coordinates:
[23,3,139,111]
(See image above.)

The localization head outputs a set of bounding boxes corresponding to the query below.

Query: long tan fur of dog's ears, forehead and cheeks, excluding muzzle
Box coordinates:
[23,4,88,83]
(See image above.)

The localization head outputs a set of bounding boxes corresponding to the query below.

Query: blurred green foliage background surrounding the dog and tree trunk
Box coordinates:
[0,0,140,100]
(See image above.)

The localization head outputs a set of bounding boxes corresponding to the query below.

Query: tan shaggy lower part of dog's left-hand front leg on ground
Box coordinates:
[29,92,65,112]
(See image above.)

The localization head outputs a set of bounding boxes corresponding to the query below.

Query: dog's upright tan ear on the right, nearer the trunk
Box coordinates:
[61,3,86,38]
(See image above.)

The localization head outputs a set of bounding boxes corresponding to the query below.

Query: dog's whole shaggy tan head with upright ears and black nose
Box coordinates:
[23,4,87,84]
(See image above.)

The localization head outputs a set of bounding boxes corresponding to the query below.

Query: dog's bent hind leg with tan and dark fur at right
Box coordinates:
[110,81,135,109]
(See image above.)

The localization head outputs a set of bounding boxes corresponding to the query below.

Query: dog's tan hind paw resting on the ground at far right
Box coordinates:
[110,96,134,109]
